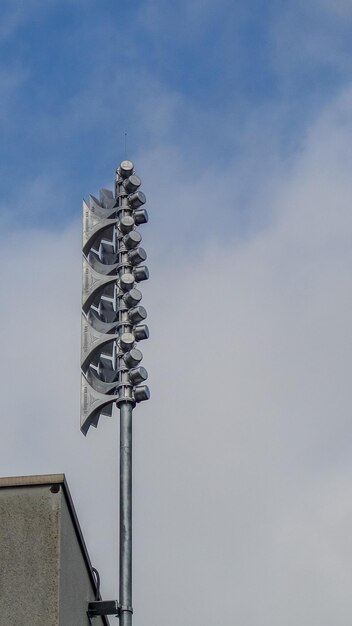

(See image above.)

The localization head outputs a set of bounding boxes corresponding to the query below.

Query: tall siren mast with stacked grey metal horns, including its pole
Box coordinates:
[81,160,150,626]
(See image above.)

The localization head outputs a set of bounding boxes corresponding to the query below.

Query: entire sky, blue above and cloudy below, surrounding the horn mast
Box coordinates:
[0,0,352,626]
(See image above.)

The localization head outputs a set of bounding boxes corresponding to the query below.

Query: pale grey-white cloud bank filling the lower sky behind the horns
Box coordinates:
[0,85,352,626]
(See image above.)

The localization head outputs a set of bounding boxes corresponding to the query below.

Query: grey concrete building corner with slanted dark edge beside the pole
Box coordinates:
[0,479,107,626]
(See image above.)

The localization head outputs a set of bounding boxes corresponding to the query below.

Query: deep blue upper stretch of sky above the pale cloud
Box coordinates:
[0,0,351,234]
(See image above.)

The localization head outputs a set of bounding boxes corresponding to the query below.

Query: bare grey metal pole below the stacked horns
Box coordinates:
[119,402,133,626]
